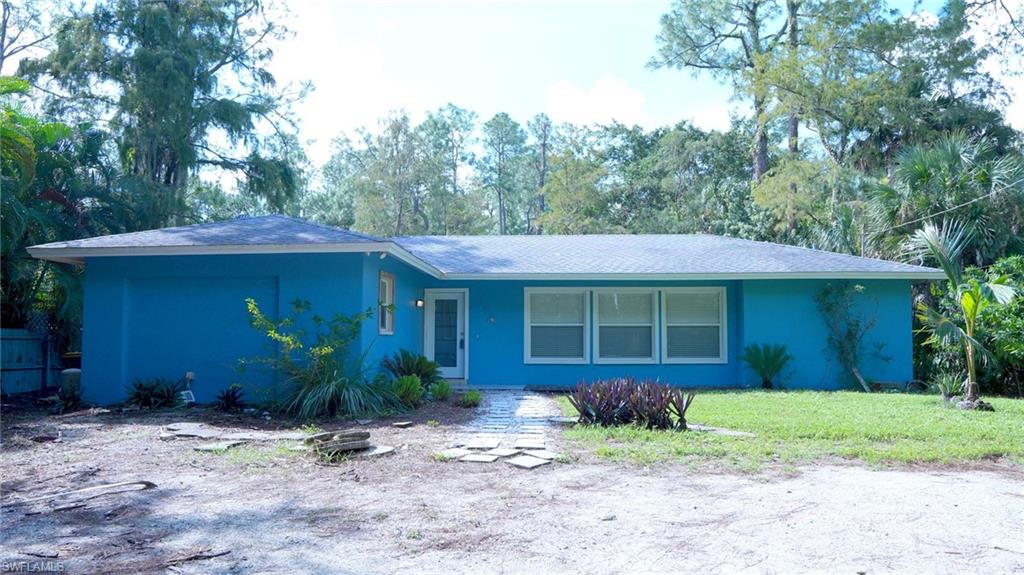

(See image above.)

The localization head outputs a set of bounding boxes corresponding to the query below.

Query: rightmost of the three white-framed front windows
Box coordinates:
[662,288,727,363]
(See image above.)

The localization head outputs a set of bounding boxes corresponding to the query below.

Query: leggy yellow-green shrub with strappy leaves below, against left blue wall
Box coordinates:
[241,298,401,419]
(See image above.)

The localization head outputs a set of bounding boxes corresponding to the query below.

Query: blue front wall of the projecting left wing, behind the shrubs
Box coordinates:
[82,253,376,403]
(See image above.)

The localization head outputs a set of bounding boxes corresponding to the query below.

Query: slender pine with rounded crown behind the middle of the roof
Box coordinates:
[477,112,526,234]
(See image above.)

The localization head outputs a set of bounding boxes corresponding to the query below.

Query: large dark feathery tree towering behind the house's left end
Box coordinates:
[20,0,296,227]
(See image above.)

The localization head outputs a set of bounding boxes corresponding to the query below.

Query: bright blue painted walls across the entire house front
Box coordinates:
[77,253,912,403]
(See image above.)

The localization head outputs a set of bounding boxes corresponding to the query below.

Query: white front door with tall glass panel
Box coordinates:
[423,290,468,380]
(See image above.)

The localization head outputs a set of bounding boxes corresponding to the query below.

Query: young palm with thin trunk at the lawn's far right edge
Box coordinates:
[907,221,1017,405]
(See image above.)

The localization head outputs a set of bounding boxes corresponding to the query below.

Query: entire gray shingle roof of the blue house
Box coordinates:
[29,216,942,279]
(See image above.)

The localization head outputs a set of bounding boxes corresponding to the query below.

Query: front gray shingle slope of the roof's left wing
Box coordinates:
[35,215,380,249]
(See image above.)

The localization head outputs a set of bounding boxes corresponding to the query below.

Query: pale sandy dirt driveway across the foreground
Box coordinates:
[0,406,1024,574]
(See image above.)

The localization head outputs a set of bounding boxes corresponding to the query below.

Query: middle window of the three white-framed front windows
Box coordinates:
[594,290,657,363]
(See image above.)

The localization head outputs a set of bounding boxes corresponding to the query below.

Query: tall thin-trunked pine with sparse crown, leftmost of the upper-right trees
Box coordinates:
[650,0,790,180]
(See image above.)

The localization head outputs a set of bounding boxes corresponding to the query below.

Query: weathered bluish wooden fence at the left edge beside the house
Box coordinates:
[0,328,60,395]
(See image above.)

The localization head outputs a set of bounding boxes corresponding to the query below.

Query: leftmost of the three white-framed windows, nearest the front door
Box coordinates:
[524,289,590,363]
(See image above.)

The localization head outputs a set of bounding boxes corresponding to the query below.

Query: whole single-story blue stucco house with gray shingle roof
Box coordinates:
[29,216,943,403]
